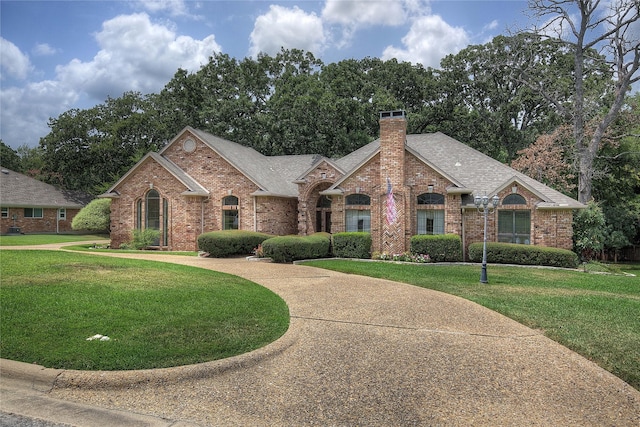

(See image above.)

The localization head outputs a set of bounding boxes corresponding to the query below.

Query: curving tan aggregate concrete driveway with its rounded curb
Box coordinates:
[0,249,640,426]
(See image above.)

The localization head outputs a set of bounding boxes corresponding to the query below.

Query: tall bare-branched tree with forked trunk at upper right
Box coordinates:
[521,0,640,203]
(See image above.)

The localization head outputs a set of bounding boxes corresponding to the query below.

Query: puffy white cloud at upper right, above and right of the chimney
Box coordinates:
[382,15,469,67]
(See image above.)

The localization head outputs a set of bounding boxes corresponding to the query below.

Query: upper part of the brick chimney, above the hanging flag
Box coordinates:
[380,110,407,188]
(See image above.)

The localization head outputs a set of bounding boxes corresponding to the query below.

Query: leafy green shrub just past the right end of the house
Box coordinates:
[573,201,606,261]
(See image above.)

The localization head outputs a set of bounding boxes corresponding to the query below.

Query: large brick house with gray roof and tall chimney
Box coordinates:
[100,111,584,254]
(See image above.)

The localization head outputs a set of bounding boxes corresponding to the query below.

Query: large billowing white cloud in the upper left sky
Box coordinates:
[56,13,221,100]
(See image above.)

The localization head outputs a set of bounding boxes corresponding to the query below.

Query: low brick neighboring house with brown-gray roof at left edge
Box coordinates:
[0,168,91,234]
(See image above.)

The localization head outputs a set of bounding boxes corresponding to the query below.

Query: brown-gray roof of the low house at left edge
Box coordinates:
[0,168,92,209]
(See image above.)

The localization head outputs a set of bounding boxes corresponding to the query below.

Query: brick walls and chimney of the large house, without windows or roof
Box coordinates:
[106,113,573,254]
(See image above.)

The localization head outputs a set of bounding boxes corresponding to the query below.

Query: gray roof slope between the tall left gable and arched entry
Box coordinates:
[189,127,318,197]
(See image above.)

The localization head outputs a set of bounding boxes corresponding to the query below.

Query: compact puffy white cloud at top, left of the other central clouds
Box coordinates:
[249,5,326,57]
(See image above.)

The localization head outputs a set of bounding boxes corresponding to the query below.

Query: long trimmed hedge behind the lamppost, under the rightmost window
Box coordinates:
[469,242,579,268]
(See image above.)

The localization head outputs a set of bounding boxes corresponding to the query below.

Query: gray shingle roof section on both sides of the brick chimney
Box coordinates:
[331,132,584,209]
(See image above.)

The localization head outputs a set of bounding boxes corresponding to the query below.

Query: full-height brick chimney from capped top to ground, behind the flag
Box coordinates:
[378,110,409,254]
